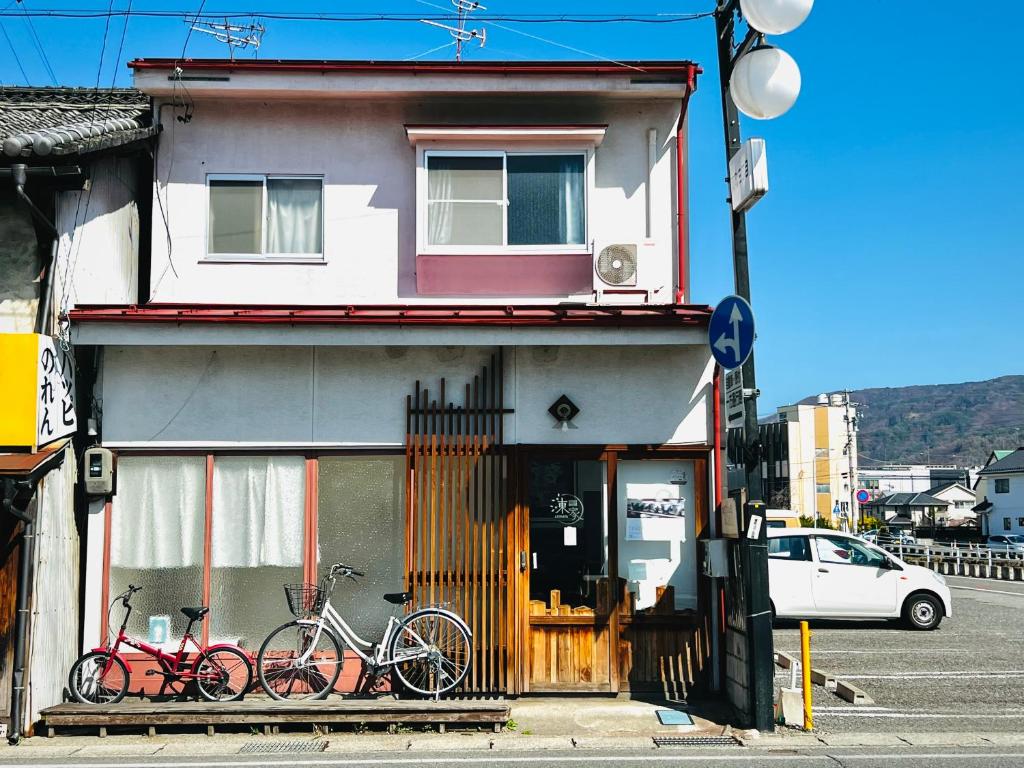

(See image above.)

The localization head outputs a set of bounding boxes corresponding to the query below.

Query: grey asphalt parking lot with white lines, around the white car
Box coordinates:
[774,577,1024,732]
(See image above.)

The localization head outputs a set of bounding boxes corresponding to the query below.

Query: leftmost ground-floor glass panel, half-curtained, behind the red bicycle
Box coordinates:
[103,456,206,644]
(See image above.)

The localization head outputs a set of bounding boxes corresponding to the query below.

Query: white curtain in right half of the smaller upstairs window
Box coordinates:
[266,178,323,254]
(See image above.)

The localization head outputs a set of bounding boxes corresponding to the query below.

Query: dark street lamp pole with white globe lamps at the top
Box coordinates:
[709,0,813,731]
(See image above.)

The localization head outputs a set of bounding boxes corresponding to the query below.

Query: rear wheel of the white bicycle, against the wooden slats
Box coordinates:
[388,608,473,696]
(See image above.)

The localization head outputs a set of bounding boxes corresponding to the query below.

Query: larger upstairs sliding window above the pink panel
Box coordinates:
[420,151,588,253]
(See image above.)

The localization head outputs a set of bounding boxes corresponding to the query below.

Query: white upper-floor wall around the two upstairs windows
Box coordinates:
[151,95,679,304]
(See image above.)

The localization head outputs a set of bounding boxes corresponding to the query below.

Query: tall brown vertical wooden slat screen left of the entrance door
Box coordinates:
[406,349,518,693]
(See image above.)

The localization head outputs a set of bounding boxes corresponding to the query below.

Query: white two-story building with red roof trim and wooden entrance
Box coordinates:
[71,59,720,693]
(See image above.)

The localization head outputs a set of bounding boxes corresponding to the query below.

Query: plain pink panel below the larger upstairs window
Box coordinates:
[416,253,593,296]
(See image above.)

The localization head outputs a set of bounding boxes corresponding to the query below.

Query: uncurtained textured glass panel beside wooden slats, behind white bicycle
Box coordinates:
[316,456,406,641]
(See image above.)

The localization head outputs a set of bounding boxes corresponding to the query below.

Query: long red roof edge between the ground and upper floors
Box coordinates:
[70,304,712,328]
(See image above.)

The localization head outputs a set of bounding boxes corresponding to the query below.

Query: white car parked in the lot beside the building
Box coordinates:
[768,528,953,630]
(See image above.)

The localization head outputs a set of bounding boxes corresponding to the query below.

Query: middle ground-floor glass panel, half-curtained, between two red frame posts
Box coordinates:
[210,456,306,649]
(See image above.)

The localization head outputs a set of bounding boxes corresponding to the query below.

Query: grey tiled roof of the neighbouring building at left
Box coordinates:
[0,87,159,158]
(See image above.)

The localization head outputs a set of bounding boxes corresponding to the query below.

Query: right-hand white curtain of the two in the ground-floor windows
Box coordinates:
[211,456,305,568]
